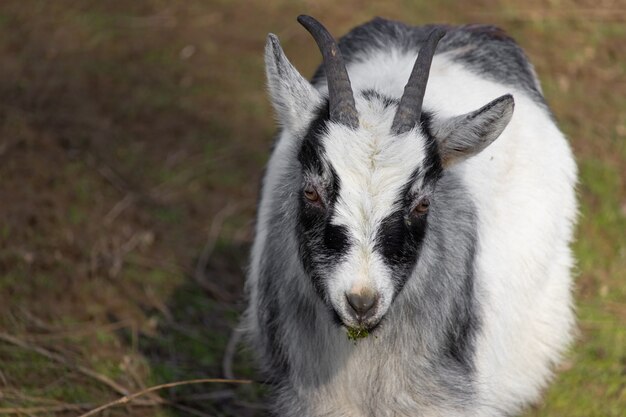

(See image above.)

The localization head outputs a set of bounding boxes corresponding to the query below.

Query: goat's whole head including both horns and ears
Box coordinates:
[265,16,514,329]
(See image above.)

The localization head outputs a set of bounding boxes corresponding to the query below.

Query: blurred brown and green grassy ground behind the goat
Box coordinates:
[0,0,626,417]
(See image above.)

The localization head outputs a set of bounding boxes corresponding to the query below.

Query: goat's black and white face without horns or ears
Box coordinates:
[297,92,442,329]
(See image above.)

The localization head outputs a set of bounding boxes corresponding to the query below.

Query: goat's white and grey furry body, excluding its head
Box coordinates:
[247,19,576,417]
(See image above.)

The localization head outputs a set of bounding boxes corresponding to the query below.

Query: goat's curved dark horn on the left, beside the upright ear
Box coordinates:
[298,15,359,128]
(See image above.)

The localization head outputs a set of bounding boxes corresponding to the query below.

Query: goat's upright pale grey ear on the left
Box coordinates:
[265,33,322,133]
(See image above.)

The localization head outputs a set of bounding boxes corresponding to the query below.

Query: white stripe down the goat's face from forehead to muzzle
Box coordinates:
[323,97,425,314]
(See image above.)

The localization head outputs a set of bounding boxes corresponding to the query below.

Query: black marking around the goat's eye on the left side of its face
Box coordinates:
[296,103,350,303]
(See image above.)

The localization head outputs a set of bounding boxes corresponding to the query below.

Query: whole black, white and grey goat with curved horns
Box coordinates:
[244,16,577,417]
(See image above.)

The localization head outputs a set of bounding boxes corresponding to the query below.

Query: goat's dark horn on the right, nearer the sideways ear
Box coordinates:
[391,28,446,135]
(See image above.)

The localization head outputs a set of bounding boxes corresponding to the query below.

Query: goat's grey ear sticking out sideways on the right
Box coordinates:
[432,94,515,168]
